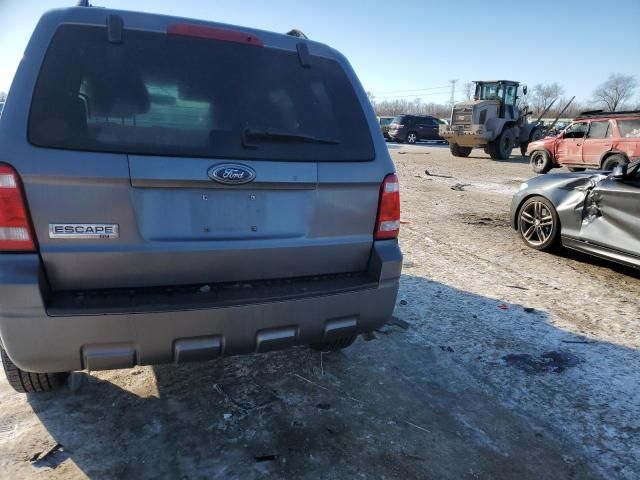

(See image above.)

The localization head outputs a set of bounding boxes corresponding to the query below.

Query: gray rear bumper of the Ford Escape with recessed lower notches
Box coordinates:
[0,241,402,373]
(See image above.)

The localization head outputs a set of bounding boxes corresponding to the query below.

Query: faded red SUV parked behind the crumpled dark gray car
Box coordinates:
[527,111,640,173]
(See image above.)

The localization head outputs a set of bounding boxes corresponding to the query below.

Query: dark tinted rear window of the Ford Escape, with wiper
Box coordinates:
[29,25,374,161]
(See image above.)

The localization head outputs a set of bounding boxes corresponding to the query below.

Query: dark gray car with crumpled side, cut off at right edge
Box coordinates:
[511,160,640,268]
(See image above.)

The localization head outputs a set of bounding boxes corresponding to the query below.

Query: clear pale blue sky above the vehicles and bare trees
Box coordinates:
[0,0,640,102]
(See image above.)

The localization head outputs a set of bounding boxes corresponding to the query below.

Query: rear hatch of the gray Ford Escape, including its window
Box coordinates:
[23,19,388,290]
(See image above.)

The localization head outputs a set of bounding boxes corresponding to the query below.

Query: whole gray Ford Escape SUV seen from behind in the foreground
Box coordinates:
[0,7,402,392]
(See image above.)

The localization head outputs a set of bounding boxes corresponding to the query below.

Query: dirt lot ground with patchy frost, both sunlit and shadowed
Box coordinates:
[0,145,640,480]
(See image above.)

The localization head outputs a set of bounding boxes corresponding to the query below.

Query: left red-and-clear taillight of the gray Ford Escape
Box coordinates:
[0,165,36,252]
